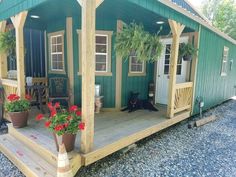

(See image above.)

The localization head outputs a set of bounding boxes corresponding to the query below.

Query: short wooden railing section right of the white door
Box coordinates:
[174,82,193,113]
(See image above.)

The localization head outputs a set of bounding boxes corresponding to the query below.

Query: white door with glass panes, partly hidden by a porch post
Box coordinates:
[155,37,188,104]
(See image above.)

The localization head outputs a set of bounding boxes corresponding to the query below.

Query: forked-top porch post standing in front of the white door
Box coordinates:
[167,20,185,118]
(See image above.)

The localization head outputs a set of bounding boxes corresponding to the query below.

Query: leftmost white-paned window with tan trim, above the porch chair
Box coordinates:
[49,31,65,73]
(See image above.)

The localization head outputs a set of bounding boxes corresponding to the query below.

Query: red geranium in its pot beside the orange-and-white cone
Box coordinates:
[36,102,85,152]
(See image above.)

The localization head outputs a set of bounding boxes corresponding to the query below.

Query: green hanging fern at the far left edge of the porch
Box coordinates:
[0,31,16,57]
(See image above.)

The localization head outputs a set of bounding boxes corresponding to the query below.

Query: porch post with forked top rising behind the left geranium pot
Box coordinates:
[11,11,28,97]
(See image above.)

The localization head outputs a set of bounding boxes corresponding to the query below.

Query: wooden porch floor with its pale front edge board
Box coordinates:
[1,106,190,174]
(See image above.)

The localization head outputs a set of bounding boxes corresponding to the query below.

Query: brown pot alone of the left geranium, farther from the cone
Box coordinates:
[8,111,29,128]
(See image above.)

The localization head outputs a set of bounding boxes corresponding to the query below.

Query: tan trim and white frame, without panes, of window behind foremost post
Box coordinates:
[77,30,113,76]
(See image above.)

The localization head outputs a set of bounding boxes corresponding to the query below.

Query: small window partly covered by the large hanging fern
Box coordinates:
[129,56,145,74]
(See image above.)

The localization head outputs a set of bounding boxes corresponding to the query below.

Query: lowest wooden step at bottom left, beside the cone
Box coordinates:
[0,134,57,177]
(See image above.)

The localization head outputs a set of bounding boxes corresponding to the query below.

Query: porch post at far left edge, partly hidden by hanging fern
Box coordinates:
[0,20,7,79]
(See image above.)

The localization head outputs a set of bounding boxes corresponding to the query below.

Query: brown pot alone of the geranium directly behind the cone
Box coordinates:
[53,133,76,152]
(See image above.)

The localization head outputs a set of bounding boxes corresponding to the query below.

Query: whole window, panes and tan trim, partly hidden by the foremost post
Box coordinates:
[77,30,112,76]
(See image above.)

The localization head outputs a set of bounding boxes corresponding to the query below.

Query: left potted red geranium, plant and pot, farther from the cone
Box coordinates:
[5,94,31,128]
